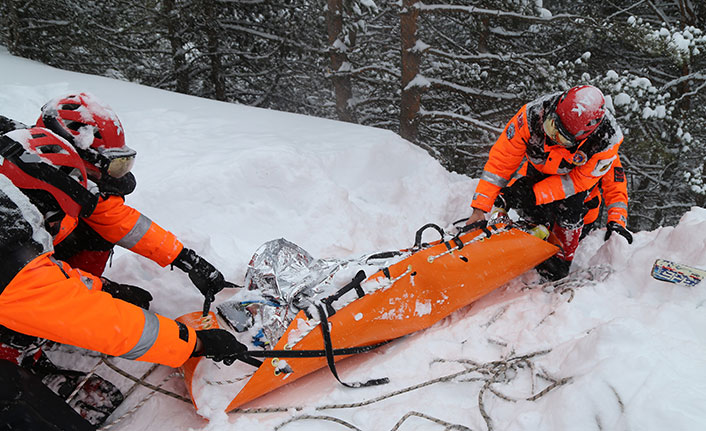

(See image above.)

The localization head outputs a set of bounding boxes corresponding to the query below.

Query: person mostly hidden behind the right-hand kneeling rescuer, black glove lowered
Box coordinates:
[581,157,632,244]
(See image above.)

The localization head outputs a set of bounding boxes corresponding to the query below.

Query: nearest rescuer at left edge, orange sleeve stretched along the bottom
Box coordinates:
[0,127,246,430]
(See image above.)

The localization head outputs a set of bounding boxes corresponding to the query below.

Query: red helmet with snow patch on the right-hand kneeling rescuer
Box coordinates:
[554,85,605,145]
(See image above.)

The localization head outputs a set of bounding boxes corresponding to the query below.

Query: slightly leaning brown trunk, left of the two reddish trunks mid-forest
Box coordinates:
[326,0,357,123]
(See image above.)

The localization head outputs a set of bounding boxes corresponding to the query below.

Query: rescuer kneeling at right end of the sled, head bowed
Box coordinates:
[467,85,623,280]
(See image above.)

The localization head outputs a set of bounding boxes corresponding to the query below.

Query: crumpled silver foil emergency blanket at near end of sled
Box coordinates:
[239,238,345,348]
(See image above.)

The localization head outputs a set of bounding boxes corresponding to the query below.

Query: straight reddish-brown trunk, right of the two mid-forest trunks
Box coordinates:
[400,0,421,143]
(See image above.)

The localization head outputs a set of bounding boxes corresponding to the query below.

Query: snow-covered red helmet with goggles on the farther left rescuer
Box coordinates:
[37,93,137,178]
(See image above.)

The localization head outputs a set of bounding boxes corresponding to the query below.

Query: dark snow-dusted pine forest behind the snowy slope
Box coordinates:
[0,0,706,230]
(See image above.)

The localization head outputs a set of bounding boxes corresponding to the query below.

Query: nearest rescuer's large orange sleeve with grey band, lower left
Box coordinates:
[0,252,196,367]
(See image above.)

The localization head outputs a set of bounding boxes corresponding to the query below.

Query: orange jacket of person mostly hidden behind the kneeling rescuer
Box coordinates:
[583,158,628,228]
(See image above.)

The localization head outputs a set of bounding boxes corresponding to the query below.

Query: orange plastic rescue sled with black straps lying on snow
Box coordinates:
[176,225,558,411]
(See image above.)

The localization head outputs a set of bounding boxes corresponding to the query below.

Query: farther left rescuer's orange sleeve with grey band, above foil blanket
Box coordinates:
[83,196,184,267]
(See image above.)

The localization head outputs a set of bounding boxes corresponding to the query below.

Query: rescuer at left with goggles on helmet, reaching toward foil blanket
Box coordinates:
[37,93,235,301]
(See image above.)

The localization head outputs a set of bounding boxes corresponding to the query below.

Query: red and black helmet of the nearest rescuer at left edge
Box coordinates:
[0,127,98,218]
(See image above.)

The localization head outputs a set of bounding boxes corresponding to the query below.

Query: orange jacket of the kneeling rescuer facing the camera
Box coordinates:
[471,93,623,212]
